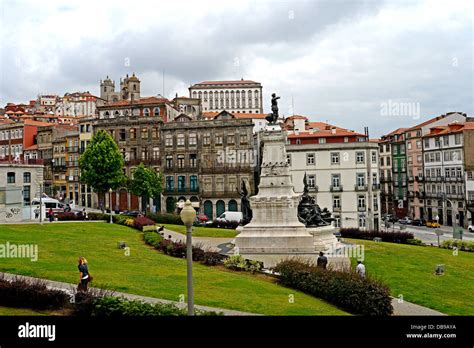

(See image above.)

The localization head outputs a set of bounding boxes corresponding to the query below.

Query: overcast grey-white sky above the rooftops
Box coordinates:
[0,0,474,137]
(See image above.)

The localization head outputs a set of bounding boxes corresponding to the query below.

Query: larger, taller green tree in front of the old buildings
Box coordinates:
[79,130,126,201]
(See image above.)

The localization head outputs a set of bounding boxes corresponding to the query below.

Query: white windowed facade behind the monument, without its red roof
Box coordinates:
[286,141,381,230]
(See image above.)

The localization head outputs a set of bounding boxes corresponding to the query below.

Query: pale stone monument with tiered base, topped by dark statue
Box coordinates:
[234,94,338,267]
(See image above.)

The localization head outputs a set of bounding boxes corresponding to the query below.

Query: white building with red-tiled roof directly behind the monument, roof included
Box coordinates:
[284,116,381,229]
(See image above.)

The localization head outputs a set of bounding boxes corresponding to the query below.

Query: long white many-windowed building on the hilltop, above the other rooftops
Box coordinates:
[189,79,263,114]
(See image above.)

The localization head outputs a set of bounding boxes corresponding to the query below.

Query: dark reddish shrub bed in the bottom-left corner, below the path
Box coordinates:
[0,277,70,309]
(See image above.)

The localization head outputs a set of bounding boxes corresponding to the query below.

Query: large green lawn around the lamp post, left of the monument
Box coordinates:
[0,222,347,315]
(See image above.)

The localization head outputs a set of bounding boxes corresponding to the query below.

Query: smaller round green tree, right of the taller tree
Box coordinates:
[128,163,163,210]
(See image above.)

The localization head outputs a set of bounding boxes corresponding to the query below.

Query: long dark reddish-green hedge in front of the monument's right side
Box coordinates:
[274,260,393,315]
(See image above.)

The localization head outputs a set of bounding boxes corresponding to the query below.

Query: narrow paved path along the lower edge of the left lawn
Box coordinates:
[0,272,261,316]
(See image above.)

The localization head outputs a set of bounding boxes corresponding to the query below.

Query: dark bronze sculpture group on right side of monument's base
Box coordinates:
[298,173,334,227]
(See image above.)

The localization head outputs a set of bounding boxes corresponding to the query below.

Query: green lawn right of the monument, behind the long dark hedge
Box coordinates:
[344,239,474,315]
